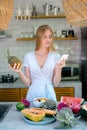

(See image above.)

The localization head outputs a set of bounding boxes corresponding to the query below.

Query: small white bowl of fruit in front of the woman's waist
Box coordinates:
[33,97,47,107]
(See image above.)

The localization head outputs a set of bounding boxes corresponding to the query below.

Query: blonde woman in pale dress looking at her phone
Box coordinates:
[10,25,65,101]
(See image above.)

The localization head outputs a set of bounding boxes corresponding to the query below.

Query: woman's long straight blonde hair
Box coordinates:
[35,25,55,51]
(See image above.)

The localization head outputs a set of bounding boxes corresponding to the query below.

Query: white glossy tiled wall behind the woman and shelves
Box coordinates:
[0,0,81,75]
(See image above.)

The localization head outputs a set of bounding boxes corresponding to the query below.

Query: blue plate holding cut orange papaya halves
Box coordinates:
[21,108,56,125]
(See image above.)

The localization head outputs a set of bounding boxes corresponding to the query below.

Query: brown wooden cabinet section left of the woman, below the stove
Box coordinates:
[0,88,27,102]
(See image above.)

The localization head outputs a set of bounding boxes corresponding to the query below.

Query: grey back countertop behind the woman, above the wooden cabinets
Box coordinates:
[0,79,82,97]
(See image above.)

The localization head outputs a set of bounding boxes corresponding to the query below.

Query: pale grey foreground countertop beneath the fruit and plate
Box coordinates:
[0,102,87,130]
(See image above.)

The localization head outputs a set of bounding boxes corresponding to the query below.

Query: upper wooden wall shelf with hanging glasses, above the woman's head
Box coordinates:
[15,14,65,19]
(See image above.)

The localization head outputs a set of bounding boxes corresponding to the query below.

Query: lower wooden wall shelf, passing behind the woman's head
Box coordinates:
[16,37,78,41]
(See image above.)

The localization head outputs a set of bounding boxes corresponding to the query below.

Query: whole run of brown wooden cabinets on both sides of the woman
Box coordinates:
[0,87,74,102]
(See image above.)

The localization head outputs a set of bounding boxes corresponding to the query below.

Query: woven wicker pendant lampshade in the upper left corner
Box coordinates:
[0,0,14,30]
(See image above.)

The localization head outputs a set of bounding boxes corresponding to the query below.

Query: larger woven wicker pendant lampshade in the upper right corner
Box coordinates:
[62,0,87,26]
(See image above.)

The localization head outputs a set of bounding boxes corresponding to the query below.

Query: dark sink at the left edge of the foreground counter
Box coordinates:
[0,104,12,122]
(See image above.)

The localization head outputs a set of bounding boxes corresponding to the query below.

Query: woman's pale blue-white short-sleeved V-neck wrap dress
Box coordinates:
[23,51,60,101]
